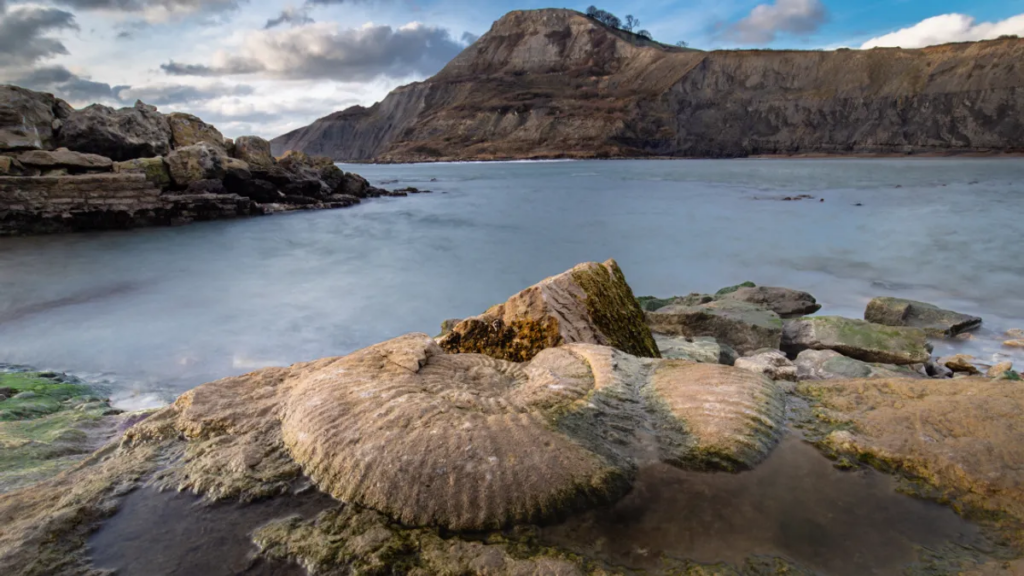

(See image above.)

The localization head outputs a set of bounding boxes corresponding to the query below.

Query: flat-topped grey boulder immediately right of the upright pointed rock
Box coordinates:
[646,300,782,354]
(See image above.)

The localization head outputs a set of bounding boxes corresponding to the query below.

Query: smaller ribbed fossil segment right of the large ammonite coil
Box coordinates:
[646,360,785,469]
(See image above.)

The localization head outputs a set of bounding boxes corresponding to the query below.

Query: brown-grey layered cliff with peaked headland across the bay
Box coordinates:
[271,9,1024,162]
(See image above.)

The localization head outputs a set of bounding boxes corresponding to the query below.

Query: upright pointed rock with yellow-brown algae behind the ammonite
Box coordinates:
[439,260,658,362]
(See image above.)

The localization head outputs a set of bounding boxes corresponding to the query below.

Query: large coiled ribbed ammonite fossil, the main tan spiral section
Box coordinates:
[282,334,631,530]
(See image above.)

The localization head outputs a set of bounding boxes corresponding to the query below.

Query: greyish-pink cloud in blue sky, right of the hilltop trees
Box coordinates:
[725,0,828,44]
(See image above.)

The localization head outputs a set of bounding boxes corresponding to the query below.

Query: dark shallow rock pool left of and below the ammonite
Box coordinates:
[89,489,336,576]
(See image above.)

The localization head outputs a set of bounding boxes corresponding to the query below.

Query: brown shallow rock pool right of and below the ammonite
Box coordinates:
[542,434,981,576]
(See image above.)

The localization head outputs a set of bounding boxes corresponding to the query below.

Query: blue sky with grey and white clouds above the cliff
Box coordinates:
[0,0,1024,137]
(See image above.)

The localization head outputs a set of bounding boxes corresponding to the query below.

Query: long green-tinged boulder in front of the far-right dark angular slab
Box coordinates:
[782,316,931,365]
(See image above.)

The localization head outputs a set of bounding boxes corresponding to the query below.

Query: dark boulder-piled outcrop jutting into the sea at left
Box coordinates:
[0,86,420,236]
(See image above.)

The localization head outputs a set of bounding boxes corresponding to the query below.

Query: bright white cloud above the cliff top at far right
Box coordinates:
[861,14,1024,49]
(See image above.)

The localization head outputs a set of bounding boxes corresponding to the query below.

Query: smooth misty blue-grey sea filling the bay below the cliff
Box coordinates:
[0,159,1024,407]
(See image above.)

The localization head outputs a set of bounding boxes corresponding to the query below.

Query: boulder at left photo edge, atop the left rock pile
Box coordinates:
[0,86,72,151]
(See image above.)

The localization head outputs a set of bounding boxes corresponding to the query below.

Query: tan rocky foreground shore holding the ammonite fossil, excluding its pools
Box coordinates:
[0,260,1024,576]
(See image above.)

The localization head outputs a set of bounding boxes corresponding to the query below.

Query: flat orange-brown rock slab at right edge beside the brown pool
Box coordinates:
[798,378,1024,545]
